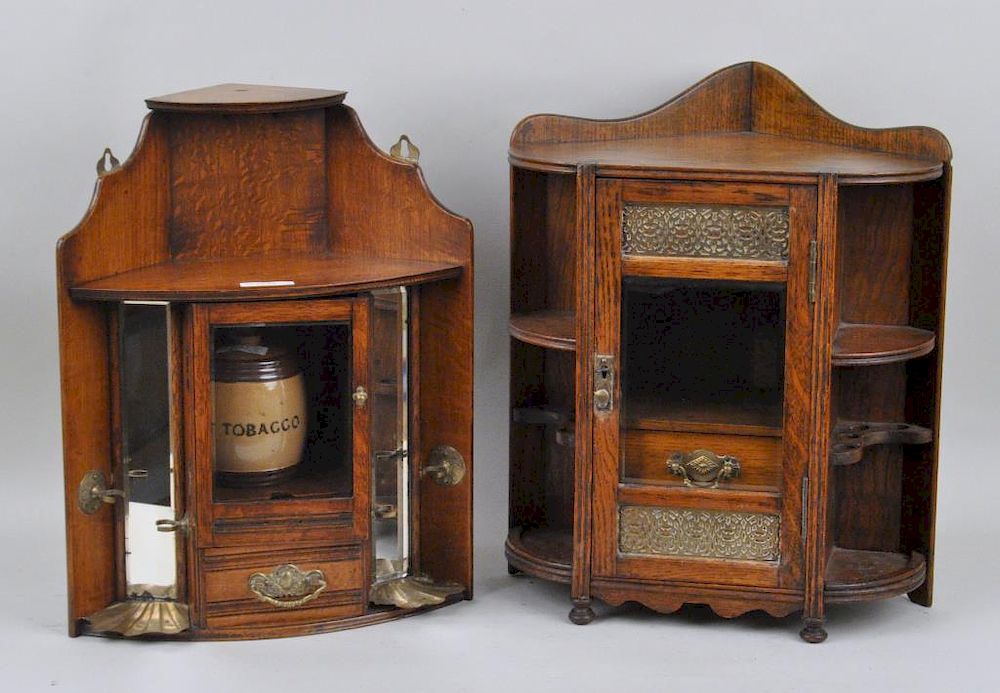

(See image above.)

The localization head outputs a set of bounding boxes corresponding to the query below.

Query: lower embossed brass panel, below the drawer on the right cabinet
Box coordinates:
[618,505,781,561]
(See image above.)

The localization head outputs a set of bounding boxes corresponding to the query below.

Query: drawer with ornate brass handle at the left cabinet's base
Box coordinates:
[201,544,366,629]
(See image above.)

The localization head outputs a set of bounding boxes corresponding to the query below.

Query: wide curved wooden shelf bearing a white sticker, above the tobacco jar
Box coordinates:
[70,251,462,301]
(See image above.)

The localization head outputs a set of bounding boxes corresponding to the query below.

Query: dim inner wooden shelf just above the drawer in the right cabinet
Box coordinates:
[623,389,782,437]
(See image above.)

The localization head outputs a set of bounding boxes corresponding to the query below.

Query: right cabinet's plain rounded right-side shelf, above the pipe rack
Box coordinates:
[832,323,935,366]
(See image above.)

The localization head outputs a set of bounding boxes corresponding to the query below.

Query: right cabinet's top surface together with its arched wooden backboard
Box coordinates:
[510,62,951,185]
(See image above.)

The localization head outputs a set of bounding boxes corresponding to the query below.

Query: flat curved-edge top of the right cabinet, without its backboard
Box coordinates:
[510,132,942,184]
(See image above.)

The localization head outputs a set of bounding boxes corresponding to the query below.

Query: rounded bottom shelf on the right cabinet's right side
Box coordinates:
[823,547,927,604]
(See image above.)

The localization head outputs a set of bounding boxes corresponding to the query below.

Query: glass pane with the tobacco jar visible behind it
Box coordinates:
[211,320,353,503]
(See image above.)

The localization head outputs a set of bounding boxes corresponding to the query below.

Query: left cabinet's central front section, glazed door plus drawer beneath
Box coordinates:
[185,296,372,635]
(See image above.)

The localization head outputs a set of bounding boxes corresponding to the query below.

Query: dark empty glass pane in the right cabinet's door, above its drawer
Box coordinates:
[621,276,785,435]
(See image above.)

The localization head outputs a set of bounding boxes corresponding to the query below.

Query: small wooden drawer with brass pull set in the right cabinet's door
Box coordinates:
[622,429,781,491]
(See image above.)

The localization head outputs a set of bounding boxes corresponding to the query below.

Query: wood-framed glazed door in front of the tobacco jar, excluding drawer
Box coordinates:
[187,296,371,548]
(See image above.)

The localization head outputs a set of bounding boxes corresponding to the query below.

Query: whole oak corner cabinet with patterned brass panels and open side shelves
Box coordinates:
[506,63,951,642]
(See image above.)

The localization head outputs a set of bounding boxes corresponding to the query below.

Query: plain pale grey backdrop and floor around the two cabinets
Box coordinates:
[0,0,1000,691]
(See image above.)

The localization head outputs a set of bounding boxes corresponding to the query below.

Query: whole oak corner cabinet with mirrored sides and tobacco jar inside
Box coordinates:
[57,84,473,639]
